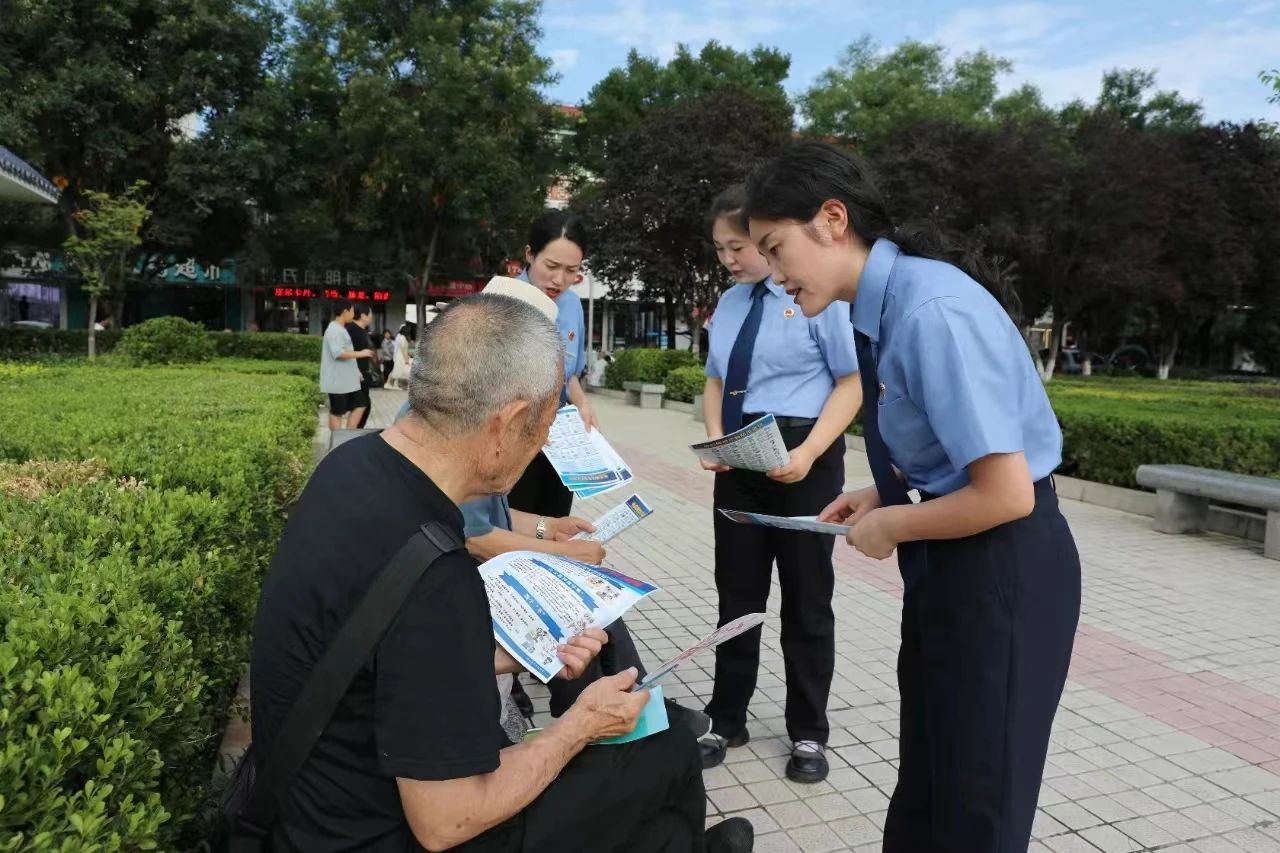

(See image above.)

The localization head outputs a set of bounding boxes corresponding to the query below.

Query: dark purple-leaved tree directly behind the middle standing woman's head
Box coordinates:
[581,90,791,348]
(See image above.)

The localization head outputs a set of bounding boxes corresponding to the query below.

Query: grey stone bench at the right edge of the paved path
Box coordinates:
[1137,465,1280,560]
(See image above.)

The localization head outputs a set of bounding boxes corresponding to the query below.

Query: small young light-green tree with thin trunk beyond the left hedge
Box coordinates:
[63,181,150,359]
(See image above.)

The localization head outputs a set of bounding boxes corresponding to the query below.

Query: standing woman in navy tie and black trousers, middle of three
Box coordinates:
[700,186,863,783]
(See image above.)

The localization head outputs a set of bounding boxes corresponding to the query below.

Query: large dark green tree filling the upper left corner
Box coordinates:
[0,0,280,237]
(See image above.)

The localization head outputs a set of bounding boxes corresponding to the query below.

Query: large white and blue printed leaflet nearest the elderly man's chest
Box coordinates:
[480,551,658,684]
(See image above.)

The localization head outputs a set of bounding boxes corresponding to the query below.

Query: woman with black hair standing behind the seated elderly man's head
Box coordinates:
[509,210,596,519]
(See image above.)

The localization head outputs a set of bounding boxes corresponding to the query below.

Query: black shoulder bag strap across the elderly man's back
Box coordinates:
[229,521,463,853]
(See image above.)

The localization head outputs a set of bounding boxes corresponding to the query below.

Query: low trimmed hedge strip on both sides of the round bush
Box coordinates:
[0,327,320,364]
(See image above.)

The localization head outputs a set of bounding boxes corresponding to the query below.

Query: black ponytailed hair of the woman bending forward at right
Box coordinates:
[744,141,1021,321]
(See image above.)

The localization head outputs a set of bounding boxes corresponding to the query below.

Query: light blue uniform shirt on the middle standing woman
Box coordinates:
[707,278,858,418]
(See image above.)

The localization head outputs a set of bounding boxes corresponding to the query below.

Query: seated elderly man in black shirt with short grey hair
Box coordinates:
[251,289,751,853]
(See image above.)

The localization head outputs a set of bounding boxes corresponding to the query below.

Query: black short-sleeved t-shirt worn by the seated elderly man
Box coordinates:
[251,435,508,853]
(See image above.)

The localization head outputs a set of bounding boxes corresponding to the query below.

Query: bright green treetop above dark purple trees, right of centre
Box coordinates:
[800,37,1048,151]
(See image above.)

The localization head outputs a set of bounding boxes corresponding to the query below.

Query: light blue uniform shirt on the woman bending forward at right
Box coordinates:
[851,240,1062,494]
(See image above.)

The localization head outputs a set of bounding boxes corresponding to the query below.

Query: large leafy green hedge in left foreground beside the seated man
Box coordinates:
[0,365,316,850]
